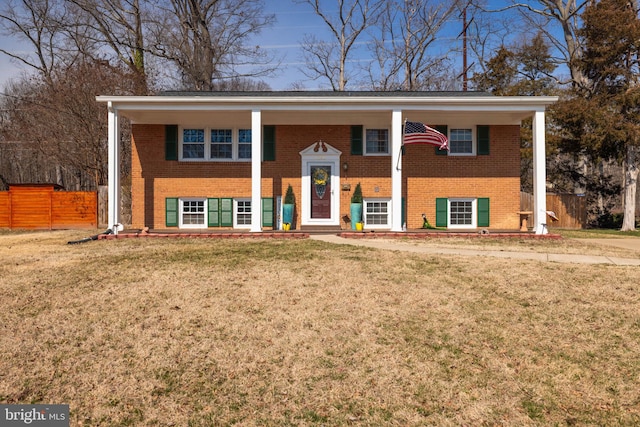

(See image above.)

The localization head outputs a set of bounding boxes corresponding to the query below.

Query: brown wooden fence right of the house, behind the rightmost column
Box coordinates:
[520,192,587,228]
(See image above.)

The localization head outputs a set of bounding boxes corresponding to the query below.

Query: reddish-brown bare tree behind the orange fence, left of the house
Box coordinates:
[0,62,131,190]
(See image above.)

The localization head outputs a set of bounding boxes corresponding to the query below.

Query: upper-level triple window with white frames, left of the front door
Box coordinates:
[179,127,251,161]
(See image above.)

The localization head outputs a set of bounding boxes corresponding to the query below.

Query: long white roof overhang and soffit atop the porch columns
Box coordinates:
[96,94,558,125]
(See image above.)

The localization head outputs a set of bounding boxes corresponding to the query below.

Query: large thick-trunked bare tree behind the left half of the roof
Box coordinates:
[149,0,278,91]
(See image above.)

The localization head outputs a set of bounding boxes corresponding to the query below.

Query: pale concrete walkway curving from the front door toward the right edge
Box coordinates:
[309,234,640,266]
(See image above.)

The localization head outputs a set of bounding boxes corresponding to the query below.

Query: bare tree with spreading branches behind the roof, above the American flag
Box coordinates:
[368,0,463,90]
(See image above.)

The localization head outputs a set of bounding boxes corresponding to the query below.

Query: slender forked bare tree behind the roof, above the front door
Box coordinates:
[297,0,384,91]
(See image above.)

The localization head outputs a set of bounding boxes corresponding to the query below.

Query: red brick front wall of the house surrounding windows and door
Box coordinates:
[132,125,520,229]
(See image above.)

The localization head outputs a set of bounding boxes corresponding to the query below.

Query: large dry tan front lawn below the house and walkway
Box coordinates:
[0,232,640,426]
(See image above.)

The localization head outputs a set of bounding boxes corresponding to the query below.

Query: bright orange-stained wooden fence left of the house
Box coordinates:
[0,184,98,230]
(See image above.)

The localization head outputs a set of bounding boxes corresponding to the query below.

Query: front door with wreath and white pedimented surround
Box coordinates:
[300,142,342,226]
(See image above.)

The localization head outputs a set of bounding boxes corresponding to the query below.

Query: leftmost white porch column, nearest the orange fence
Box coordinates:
[107,102,120,234]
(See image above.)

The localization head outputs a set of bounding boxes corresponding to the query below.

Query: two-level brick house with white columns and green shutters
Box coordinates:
[97,92,557,234]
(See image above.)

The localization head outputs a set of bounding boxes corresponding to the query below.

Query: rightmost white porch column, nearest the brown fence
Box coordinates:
[533,111,549,234]
